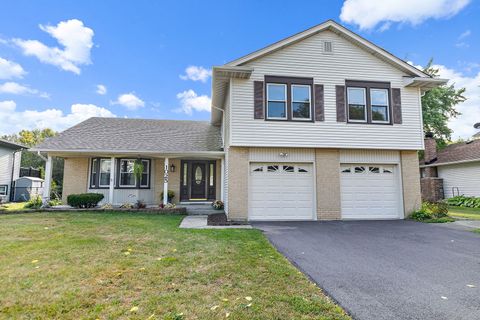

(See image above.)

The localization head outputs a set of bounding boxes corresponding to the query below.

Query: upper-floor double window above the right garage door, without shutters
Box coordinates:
[346,81,391,124]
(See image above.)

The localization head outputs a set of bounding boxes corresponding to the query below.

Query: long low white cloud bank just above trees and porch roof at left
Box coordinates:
[0,100,115,135]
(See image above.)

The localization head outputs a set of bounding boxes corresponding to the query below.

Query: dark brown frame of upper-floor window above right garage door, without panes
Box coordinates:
[345,80,393,125]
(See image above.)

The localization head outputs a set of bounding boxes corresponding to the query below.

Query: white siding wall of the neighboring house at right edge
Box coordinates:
[437,161,480,198]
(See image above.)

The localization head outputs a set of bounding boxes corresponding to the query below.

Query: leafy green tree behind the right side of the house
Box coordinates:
[422,60,467,147]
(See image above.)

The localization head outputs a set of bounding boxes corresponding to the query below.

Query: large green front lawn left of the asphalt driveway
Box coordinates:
[0,213,349,319]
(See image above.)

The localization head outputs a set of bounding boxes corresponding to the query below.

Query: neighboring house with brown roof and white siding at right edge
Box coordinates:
[420,134,480,201]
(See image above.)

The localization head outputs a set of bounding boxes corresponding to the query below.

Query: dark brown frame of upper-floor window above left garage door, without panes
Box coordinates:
[263,75,315,122]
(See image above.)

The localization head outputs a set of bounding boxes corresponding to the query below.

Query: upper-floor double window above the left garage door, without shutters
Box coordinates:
[265,76,313,121]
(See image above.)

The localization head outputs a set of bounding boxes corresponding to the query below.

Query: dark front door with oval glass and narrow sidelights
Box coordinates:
[180,160,216,201]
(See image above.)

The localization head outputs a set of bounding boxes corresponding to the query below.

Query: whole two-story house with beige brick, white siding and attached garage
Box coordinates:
[36,21,446,220]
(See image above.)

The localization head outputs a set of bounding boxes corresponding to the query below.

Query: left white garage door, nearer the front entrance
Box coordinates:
[248,163,314,220]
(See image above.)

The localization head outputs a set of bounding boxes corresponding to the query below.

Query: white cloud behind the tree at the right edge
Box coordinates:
[434,65,480,139]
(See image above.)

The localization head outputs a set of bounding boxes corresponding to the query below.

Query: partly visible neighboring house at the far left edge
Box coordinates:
[0,139,26,203]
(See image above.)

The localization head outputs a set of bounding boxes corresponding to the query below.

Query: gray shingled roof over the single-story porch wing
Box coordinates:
[35,118,222,153]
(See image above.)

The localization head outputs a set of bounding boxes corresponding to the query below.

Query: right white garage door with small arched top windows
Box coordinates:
[340,164,402,219]
